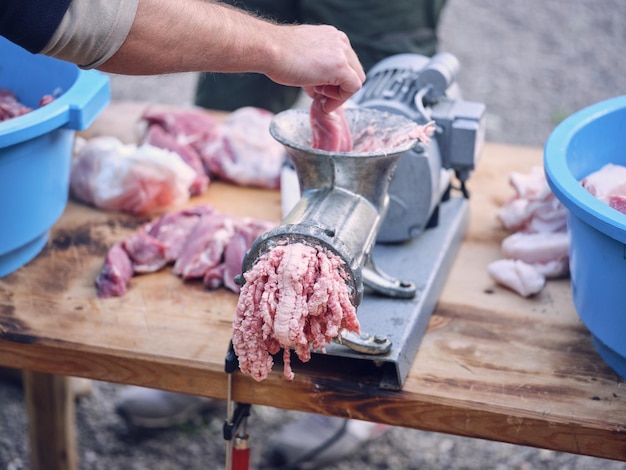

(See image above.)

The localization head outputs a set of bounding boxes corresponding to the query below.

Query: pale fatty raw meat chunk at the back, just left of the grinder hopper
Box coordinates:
[199,106,285,189]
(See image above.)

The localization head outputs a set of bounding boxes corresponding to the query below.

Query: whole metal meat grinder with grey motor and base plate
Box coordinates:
[243,54,485,389]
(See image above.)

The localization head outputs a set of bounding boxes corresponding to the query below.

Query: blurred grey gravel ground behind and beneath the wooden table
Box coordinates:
[0,0,626,470]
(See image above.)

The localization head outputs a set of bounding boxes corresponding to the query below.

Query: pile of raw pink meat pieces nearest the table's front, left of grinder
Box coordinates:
[96,204,276,297]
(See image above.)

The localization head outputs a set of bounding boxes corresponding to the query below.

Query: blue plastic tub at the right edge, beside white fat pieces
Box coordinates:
[544,96,626,378]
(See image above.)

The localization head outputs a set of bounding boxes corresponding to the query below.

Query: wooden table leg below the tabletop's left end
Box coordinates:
[23,371,78,470]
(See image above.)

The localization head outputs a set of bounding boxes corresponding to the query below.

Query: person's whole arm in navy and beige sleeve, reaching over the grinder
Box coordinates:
[0,0,365,108]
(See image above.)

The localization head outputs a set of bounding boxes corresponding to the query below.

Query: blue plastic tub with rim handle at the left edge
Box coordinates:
[0,37,110,277]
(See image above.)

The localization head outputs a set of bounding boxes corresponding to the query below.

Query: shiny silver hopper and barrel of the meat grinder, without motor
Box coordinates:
[243,108,417,306]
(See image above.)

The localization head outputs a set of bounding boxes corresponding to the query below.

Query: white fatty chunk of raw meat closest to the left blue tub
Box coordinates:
[70,137,196,215]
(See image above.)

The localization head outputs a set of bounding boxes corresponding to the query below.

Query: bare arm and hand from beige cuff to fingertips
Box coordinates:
[99,0,365,111]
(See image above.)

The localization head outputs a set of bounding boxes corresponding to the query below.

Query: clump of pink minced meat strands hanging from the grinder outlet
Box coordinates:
[233,243,360,381]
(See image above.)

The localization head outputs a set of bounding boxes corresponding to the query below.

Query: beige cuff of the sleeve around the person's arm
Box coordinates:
[41,0,139,69]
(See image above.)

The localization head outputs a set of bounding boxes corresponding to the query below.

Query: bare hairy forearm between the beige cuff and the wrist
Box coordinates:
[100,0,276,75]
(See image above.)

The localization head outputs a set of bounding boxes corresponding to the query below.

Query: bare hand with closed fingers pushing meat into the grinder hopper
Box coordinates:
[265,25,365,113]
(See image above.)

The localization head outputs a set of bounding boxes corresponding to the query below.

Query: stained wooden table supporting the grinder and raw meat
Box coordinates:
[0,106,626,468]
